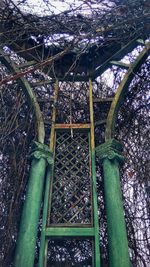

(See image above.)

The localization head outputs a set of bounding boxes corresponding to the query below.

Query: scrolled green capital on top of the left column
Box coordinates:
[29,141,54,165]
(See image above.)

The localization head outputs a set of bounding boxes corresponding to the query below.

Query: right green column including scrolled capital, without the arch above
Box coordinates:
[96,139,131,267]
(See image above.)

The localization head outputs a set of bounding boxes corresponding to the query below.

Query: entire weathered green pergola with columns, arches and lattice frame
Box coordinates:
[0,38,150,267]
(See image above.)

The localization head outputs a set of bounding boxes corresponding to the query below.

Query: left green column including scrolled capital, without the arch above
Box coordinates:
[14,142,53,267]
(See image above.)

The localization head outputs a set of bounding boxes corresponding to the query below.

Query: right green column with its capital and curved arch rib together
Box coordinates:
[96,42,150,267]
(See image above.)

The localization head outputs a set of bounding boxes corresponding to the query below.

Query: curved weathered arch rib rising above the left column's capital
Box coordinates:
[0,49,45,144]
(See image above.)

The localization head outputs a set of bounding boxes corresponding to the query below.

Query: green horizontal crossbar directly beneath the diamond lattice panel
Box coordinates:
[45,227,95,237]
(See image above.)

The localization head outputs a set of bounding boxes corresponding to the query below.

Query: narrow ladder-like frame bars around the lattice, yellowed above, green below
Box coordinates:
[38,79,100,267]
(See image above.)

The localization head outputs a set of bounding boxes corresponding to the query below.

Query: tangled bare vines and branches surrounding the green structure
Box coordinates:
[0,0,150,267]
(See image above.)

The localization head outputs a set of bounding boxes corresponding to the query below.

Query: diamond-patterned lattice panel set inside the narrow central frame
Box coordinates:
[50,131,92,224]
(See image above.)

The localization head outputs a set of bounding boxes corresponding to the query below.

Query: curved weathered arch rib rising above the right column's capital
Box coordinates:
[105,42,150,141]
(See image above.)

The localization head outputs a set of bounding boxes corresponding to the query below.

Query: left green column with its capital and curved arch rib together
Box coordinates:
[0,50,52,267]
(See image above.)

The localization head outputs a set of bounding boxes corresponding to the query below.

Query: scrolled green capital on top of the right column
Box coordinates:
[96,139,124,163]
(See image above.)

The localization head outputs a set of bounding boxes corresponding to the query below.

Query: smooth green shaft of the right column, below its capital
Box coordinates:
[103,159,131,267]
